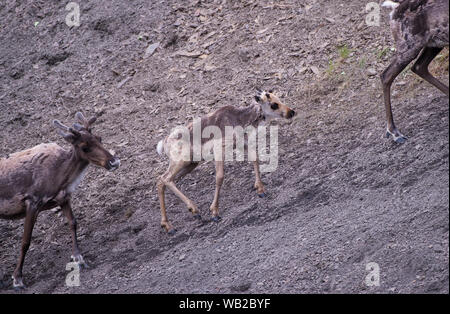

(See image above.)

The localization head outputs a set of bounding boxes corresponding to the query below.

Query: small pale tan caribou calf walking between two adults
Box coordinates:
[157,91,295,234]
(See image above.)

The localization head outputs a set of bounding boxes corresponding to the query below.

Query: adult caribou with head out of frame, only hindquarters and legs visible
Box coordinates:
[381,0,449,143]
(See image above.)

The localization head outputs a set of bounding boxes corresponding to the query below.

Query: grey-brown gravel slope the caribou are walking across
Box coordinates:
[0,0,449,293]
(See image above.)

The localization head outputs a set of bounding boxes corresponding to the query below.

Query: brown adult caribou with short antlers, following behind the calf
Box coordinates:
[0,112,120,288]
